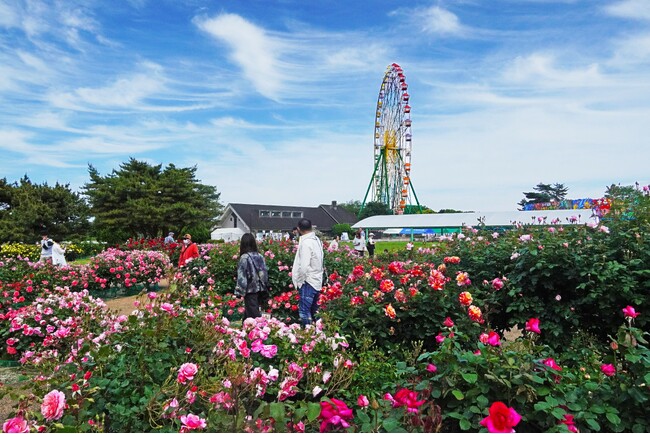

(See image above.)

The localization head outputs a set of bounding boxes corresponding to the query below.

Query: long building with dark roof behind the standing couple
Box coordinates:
[219,201,358,233]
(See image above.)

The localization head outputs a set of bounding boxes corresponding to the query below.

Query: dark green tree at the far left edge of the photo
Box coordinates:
[0,175,90,243]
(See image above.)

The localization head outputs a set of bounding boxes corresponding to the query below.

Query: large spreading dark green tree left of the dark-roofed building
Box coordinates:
[83,158,223,242]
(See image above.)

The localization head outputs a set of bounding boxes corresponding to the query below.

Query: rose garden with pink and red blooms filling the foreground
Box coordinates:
[0,194,650,432]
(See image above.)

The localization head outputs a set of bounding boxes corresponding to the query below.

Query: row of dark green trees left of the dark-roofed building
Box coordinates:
[0,158,223,243]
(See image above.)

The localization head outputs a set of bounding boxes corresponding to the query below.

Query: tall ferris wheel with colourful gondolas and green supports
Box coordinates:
[360,63,420,214]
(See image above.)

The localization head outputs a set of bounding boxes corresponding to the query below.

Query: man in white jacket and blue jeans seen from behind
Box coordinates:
[291,219,323,326]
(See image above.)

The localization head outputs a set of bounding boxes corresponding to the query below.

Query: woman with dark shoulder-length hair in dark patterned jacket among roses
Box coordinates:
[235,233,269,320]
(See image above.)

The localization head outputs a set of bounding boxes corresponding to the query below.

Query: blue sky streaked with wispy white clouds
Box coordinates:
[0,0,650,211]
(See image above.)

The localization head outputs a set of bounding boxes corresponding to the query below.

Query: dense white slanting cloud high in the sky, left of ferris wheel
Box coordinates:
[194,14,283,100]
